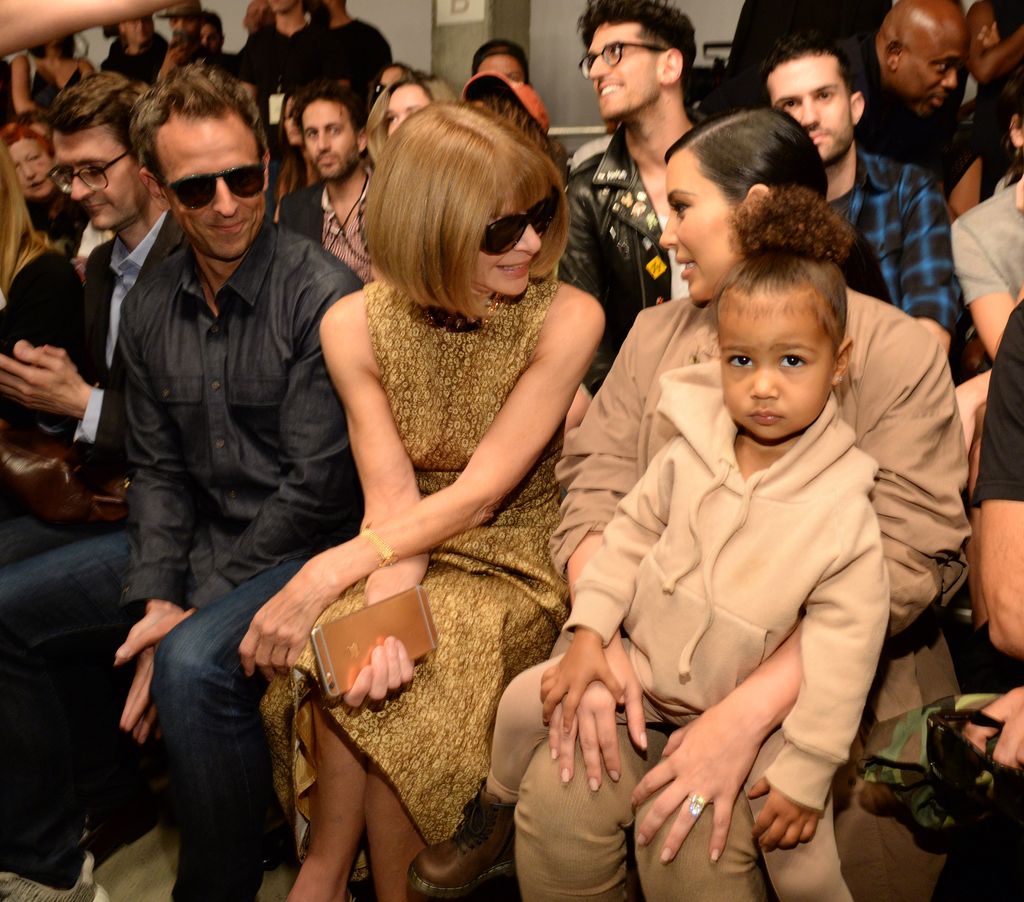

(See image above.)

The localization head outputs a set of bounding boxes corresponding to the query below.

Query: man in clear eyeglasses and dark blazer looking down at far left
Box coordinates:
[0,73,181,566]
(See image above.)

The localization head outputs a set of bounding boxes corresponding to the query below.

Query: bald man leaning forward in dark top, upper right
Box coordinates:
[841,0,969,176]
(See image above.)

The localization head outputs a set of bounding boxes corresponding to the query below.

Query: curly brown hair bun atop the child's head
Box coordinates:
[733,185,855,266]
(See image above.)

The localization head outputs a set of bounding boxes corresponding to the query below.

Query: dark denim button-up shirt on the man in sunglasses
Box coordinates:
[121,224,361,606]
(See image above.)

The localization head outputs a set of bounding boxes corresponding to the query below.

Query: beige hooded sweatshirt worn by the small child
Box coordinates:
[567,362,889,809]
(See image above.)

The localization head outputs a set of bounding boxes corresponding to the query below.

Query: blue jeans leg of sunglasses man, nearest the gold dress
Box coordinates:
[153,560,305,902]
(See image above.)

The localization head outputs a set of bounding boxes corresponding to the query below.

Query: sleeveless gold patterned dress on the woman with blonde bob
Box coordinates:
[262,281,567,849]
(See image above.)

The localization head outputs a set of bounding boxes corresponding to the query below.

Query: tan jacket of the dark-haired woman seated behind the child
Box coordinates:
[551,292,970,720]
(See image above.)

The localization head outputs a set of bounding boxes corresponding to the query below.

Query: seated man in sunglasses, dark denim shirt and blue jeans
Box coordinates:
[0,65,361,902]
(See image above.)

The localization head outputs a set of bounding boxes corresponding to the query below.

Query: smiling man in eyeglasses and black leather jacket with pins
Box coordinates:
[558,0,696,393]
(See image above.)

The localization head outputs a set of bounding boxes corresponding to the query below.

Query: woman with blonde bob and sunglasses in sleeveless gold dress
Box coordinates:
[256,103,603,902]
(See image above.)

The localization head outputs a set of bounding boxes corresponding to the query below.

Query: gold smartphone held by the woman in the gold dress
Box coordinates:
[310,586,437,698]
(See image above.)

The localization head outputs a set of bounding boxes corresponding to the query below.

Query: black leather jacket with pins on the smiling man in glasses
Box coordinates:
[558,127,672,392]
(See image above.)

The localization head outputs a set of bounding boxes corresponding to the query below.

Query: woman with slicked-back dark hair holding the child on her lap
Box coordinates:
[515,110,968,900]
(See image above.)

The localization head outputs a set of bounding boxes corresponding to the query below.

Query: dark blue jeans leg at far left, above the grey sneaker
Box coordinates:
[0,532,131,887]
